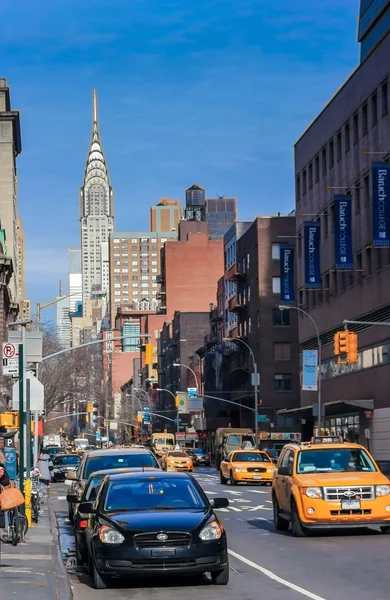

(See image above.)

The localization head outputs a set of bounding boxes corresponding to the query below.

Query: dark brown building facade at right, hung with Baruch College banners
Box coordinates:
[295,19,390,460]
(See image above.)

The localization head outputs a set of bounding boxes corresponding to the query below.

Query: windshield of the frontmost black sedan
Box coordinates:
[104,477,206,512]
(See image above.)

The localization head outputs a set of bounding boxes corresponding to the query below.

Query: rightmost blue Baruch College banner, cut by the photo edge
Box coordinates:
[372,163,390,248]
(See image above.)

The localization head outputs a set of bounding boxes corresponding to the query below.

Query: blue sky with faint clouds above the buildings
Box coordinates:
[0,0,359,310]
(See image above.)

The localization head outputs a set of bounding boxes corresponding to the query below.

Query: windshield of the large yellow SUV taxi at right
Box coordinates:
[297,448,376,473]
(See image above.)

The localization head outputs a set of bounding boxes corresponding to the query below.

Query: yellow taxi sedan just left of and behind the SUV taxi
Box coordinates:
[219,450,276,485]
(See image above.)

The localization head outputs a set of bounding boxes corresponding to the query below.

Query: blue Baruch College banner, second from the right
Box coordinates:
[334,196,353,269]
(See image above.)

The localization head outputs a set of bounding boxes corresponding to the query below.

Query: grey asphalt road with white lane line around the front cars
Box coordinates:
[51,468,390,600]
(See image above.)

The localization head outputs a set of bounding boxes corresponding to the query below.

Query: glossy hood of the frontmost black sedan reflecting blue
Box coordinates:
[107,508,211,532]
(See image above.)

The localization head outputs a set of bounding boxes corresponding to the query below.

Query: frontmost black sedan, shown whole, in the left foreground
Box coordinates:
[79,471,229,589]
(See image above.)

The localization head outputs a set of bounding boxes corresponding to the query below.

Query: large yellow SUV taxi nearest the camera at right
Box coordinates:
[272,436,390,537]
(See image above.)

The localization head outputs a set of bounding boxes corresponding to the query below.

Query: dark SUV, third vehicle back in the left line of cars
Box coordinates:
[66,448,161,522]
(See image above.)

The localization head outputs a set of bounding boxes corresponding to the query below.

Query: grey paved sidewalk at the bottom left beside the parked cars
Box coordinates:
[0,500,72,600]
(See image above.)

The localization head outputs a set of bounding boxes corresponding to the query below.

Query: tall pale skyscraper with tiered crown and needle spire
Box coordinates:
[80,90,114,316]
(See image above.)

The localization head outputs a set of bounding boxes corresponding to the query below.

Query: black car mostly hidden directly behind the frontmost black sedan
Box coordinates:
[66,469,136,565]
